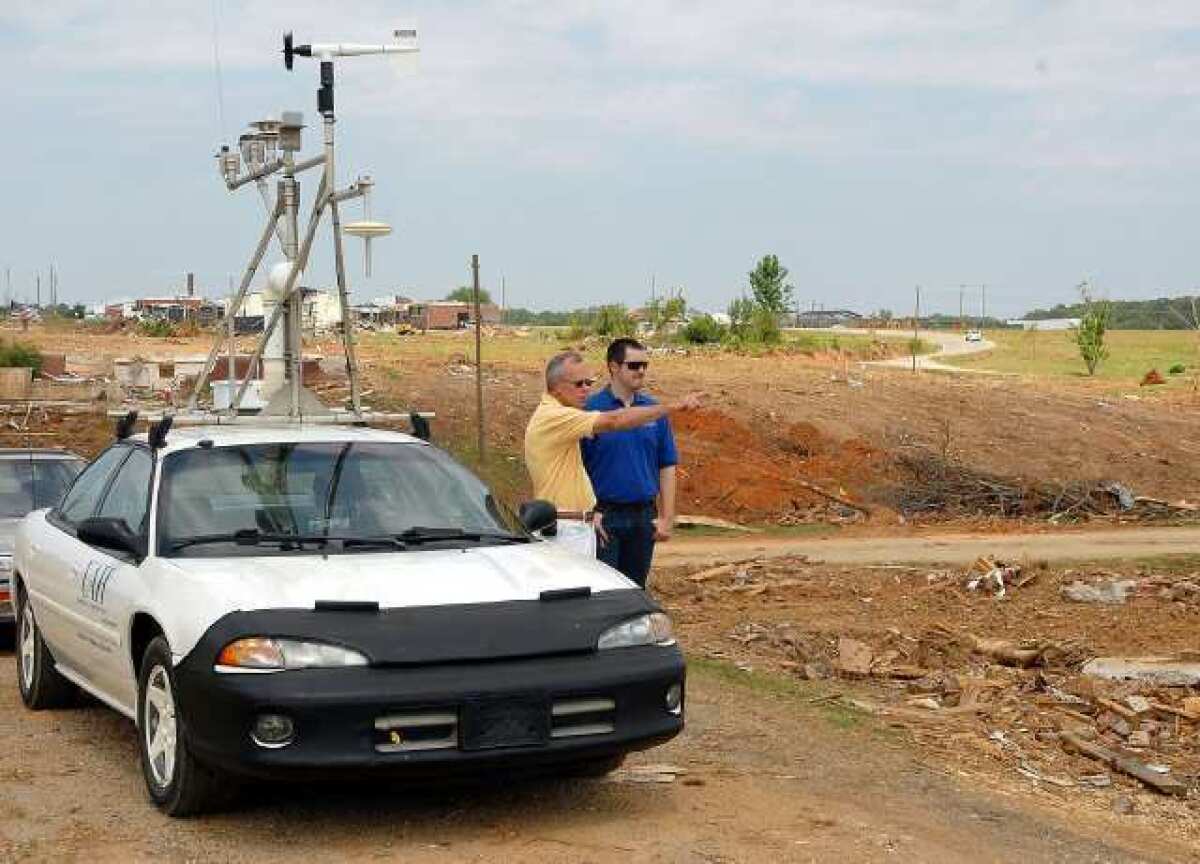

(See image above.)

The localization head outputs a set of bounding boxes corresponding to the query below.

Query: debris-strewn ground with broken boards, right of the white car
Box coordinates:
[667,556,1200,818]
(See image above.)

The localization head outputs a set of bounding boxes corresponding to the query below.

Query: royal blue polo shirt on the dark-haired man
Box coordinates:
[580,388,679,504]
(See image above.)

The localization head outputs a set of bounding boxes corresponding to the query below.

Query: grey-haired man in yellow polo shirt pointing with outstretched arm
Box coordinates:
[524,352,701,538]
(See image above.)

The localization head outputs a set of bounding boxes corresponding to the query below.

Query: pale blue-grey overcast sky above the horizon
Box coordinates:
[0,0,1200,314]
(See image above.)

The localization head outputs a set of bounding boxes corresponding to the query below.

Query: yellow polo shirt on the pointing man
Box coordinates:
[526,394,598,510]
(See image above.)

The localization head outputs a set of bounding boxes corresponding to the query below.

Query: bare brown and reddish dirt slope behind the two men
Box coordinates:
[10,328,1200,527]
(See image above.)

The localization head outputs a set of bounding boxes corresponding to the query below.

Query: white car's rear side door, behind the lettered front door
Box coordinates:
[25,444,131,670]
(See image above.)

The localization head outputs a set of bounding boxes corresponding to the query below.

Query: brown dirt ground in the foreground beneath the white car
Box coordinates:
[0,649,1188,864]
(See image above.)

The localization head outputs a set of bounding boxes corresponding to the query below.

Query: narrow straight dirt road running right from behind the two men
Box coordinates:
[654,527,1200,566]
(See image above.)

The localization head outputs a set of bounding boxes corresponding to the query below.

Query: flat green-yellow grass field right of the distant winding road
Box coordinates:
[947,330,1200,382]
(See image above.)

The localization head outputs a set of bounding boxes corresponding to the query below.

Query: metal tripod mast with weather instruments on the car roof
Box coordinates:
[187,30,419,420]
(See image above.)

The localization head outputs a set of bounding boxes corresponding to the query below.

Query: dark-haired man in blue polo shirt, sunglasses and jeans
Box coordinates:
[581,338,679,588]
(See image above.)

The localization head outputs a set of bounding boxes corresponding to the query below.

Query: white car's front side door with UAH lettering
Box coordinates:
[79,444,154,707]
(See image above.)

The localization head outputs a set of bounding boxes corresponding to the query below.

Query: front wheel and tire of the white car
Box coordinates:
[137,636,233,816]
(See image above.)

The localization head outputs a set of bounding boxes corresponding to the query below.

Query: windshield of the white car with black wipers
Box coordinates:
[158,442,528,557]
